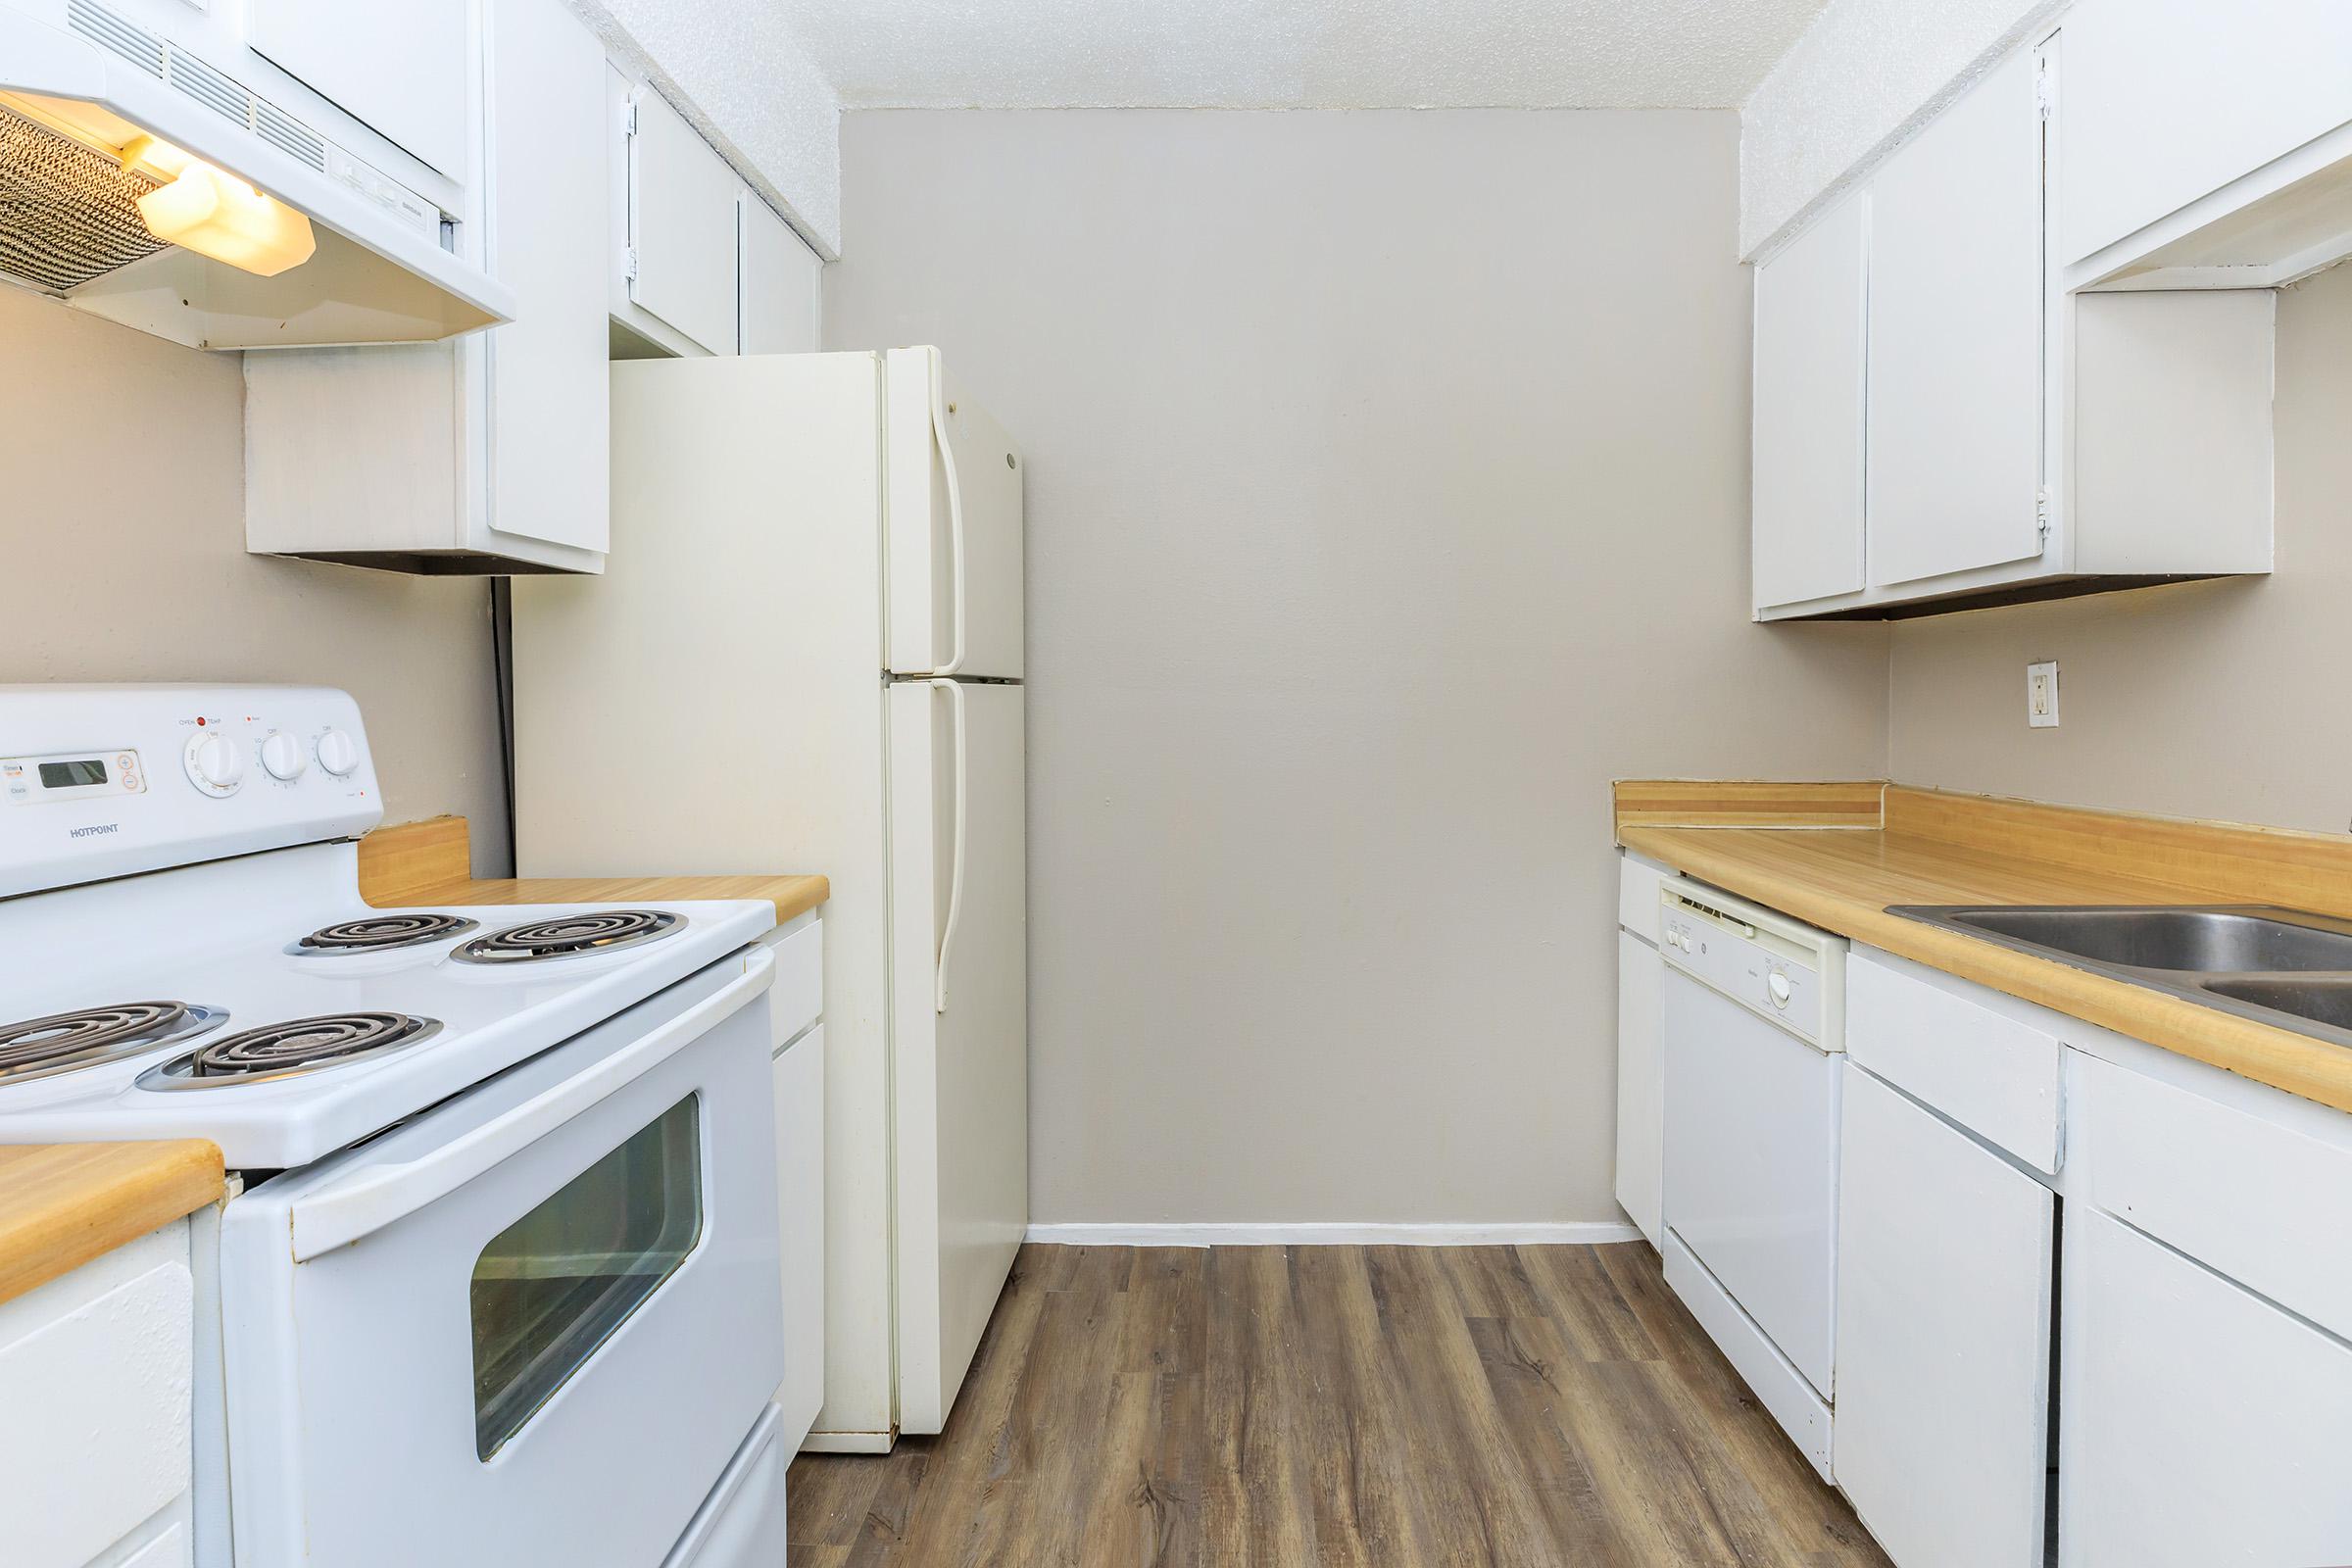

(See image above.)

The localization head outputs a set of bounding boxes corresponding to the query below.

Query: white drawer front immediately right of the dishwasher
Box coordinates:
[1846,953,2065,1171]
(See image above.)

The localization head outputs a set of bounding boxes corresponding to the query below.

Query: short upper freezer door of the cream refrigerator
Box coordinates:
[884,348,1025,679]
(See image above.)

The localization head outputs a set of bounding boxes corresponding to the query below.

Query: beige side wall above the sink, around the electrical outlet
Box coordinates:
[1888,266,2352,832]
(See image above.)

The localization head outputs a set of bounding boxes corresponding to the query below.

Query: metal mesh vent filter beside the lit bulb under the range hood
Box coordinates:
[0,108,165,294]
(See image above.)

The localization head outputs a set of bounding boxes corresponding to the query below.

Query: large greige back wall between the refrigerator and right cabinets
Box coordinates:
[825,111,1886,1222]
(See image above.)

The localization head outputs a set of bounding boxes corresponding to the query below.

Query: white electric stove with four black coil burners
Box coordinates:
[0,686,786,1568]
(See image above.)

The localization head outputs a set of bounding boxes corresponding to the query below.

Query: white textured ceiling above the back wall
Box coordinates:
[769,0,1825,108]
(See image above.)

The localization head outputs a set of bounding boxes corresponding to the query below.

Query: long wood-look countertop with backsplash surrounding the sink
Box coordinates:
[1618,783,2352,1112]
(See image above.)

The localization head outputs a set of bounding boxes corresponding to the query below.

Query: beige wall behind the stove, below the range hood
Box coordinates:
[0,287,508,870]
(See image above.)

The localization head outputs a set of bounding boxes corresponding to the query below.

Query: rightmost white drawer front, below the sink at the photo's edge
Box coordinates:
[2072,1054,2352,1338]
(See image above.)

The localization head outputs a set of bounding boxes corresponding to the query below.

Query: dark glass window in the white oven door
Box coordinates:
[472,1096,704,1460]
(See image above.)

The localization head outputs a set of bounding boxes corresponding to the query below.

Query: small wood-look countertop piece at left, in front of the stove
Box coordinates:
[0,1138,221,1302]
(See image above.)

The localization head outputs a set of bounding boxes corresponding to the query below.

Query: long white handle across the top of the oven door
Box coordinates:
[287,948,776,1262]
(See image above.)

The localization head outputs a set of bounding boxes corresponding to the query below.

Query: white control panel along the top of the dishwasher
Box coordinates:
[1658,882,1846,1051]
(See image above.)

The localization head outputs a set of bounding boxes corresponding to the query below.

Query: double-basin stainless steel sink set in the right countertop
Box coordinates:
[1886,906,2352,1046]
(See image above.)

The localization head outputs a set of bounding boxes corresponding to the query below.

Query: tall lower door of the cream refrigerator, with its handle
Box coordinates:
[889,682,1028,1434]
